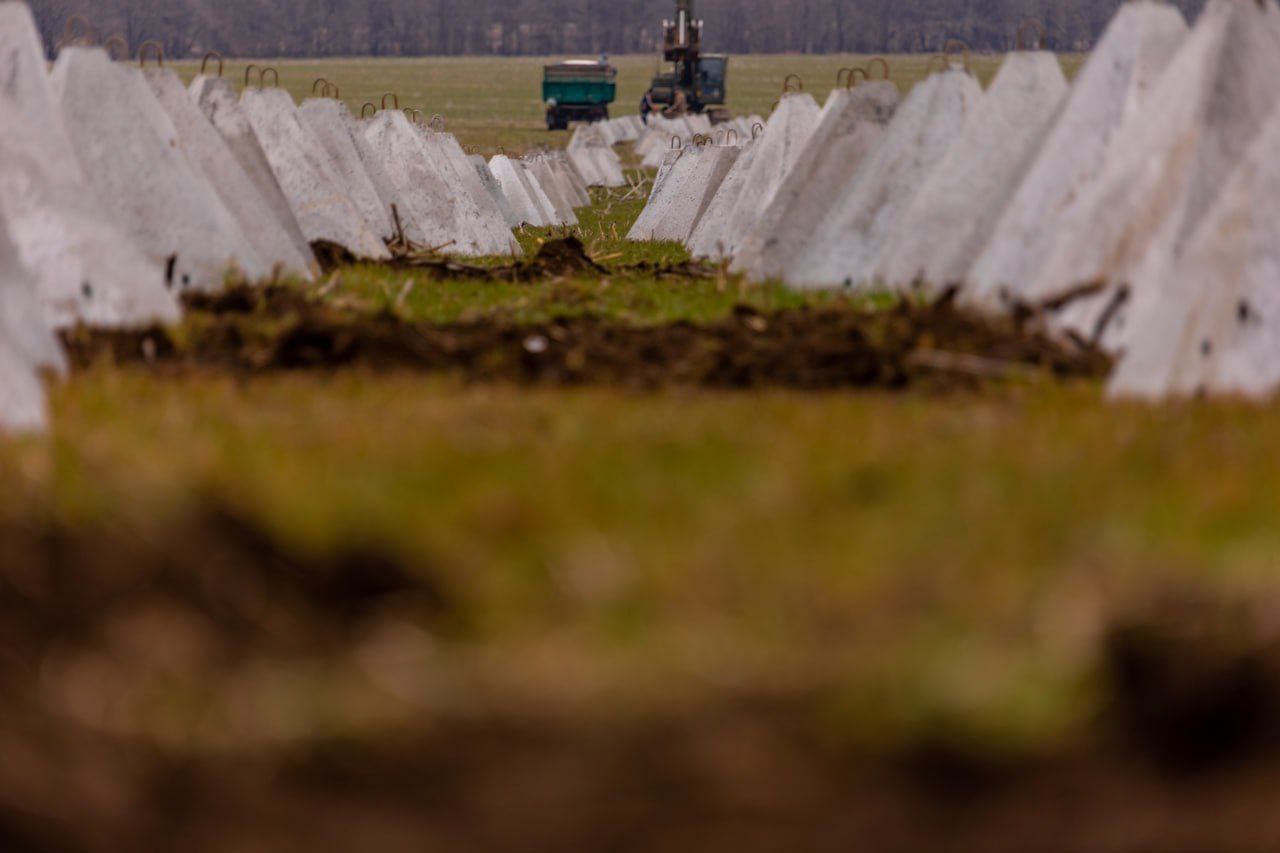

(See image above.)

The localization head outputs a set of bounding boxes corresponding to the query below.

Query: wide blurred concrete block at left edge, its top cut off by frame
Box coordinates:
[0,87,179,328]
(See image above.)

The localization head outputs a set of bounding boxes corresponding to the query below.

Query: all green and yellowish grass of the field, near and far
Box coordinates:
[0,56,1280,849]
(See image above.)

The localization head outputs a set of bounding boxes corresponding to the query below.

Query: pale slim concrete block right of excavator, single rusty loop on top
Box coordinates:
[701,92,822,256]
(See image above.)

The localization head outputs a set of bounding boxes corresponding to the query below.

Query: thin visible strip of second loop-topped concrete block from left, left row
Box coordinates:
[143,68,314,280]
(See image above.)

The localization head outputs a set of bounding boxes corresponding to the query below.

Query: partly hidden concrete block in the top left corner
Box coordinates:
[0,3,84,179]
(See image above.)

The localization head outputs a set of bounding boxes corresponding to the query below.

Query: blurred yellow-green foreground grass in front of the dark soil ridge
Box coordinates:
[15,368,1280,748]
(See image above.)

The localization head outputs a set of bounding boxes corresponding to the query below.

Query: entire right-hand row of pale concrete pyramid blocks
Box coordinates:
[632,0,1280,398]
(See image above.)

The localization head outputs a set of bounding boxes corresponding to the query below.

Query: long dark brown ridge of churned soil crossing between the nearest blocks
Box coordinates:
[65,287,1110,389]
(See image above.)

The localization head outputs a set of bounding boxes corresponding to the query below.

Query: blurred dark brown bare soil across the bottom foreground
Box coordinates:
[0,507,1280,853]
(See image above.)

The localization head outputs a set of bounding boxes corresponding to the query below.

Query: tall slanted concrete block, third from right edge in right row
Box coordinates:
[960,0,1188,311]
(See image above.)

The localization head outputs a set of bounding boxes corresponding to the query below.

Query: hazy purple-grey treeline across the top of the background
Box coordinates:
[31,0,1203,56]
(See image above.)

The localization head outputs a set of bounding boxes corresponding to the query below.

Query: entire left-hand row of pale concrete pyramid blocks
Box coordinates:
[0,3,629,428]
